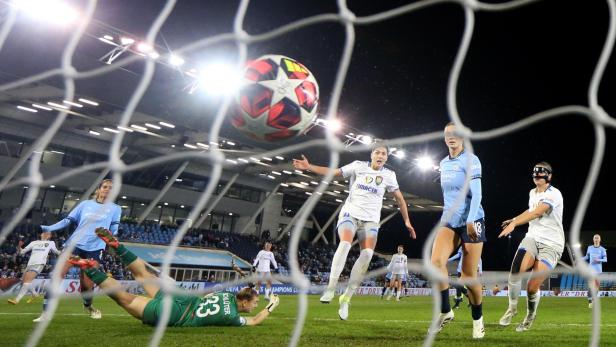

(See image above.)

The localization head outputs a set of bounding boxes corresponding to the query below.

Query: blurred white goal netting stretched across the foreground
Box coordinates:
[0,0,616,346]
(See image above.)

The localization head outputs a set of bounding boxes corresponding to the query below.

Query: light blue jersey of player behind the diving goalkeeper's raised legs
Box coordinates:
[41,200,122,251]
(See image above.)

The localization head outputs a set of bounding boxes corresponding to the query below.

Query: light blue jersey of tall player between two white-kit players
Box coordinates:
[440,151,485,228]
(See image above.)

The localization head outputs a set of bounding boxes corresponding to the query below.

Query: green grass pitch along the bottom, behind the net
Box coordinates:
[0,296,616,347]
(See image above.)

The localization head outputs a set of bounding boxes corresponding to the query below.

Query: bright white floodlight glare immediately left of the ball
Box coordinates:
[198,63,242,96]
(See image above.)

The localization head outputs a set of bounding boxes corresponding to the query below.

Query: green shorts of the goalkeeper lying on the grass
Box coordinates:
[141,290,199,326]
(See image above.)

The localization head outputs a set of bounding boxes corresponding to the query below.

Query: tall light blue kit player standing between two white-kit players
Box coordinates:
[431,123,487,339]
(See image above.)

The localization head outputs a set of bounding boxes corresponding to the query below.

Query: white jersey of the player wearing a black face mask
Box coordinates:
[526,185,565,252]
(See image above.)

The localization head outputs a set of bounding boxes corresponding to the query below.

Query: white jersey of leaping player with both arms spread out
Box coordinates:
[340,160,399,223]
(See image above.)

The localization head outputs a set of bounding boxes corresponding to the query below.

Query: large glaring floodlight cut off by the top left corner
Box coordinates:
[13,0,79,26]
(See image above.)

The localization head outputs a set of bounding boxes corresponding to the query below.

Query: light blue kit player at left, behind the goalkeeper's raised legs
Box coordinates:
[34,179,122,322]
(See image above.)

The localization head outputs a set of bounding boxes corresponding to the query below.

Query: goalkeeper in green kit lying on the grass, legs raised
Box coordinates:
[69,228,279,327]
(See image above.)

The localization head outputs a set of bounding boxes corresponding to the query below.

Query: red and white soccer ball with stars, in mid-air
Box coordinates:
[231,55,319,142]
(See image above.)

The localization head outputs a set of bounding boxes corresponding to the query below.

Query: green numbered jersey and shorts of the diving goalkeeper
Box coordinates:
[142,291,246,327]
